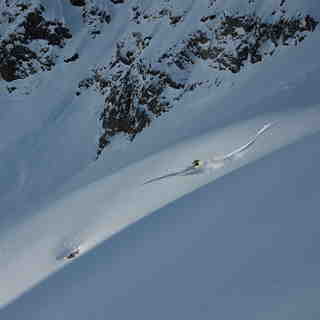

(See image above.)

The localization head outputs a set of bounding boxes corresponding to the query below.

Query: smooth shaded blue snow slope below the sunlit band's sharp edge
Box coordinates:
[2,121,320,320]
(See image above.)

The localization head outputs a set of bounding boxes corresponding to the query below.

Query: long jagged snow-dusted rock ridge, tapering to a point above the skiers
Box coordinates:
[78,8,318,157]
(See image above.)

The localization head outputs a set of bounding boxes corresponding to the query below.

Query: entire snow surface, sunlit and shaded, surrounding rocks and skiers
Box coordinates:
[0,0,320,320]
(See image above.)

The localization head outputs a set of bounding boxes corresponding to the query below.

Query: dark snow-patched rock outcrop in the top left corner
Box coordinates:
[0,5,72,81]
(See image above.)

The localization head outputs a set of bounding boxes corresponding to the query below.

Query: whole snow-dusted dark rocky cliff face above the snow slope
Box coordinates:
[0,0,318,157]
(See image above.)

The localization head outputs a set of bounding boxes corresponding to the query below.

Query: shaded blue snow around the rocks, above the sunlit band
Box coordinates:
[0,0,318,219]
